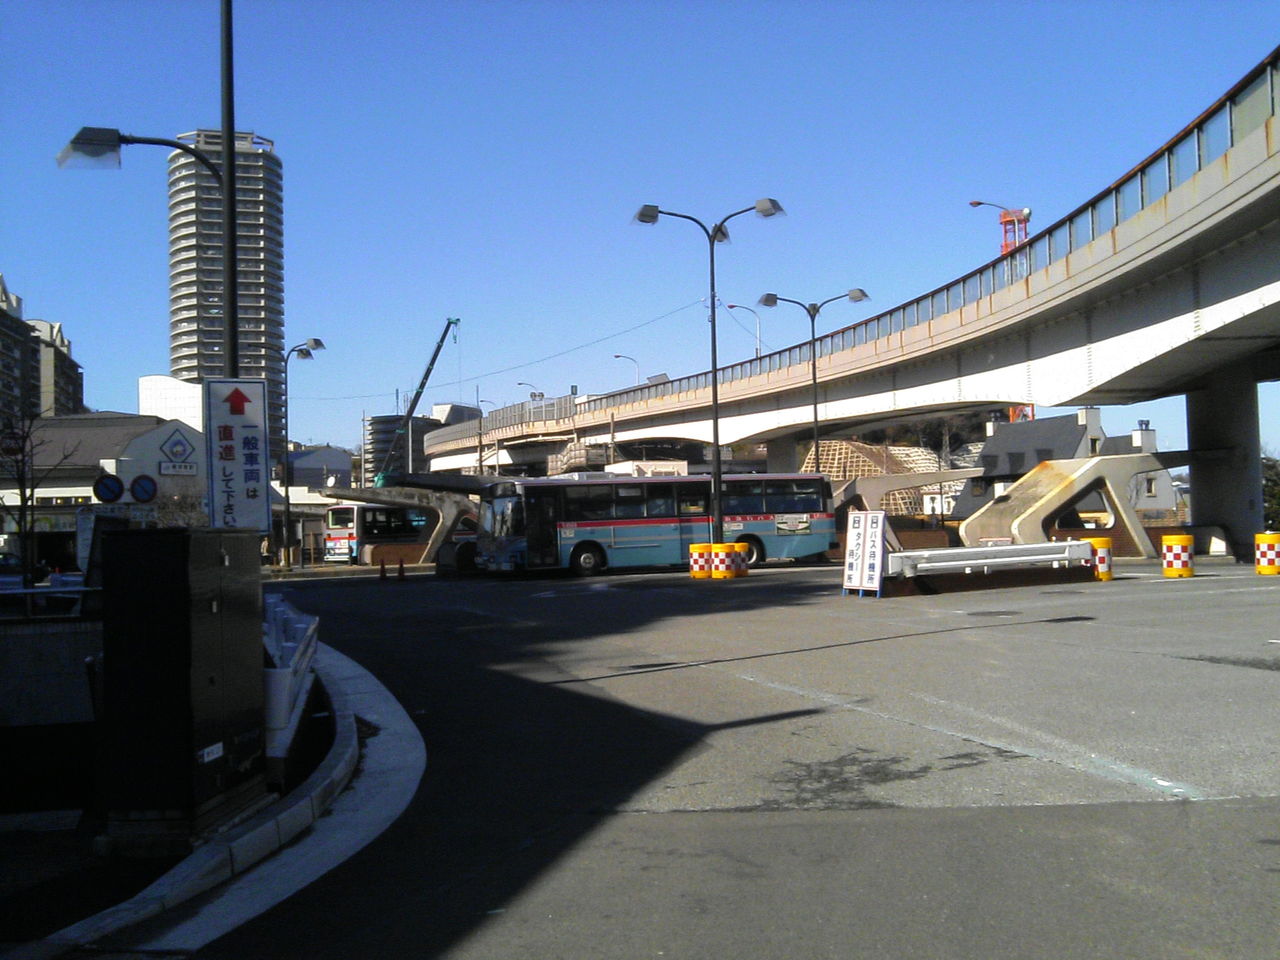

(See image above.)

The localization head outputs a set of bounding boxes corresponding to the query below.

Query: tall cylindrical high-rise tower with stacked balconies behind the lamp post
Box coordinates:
[169,131,284,458]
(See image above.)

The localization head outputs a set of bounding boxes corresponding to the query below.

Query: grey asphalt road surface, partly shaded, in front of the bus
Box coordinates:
[124,564,1280,960]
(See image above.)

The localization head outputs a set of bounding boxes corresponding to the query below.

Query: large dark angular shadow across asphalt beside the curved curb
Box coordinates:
[186,579,831,960]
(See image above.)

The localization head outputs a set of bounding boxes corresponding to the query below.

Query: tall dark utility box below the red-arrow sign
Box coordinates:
[97,529,265,855]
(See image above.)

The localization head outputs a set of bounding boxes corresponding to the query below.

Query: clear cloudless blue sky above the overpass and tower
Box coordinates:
[0,0,1280,452]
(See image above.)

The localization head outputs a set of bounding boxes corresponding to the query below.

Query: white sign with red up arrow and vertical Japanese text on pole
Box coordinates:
[202,380,271,534]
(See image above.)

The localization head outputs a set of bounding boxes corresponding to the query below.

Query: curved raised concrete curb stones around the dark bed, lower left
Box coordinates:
[0,662,360,960]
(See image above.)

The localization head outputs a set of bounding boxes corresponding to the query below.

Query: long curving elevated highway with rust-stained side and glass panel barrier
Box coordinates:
[425,49,1280,555]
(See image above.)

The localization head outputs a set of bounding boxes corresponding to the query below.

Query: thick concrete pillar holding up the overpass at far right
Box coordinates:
[1187,364,1263,563]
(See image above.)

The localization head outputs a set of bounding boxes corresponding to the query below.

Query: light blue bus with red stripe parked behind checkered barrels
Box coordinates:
[476,474,837,576]
